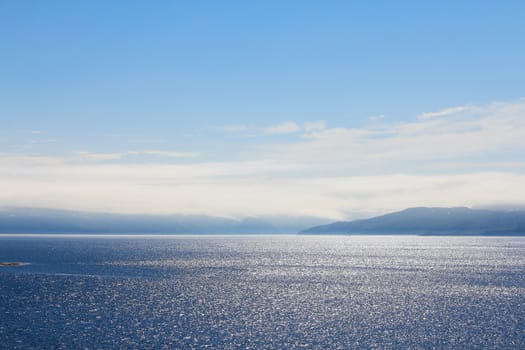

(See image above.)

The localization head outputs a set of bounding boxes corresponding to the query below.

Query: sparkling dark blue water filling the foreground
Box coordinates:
[0,236,525,349]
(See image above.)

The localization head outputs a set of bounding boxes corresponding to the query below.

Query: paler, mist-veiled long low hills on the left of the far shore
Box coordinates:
[0,208,327,234]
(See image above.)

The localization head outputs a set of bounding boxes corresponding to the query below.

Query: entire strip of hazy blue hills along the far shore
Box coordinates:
[0,207,525,236]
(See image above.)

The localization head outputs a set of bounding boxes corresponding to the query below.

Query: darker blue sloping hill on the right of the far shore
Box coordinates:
[301,207,525,235]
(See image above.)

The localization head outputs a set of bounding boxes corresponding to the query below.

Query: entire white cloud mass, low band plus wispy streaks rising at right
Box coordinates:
[0,100,525,219]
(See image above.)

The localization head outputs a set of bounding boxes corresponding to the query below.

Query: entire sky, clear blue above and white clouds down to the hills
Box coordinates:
[0,0,525,220]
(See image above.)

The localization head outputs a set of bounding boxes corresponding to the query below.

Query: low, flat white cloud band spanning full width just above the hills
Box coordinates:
[0,155,525,219]
